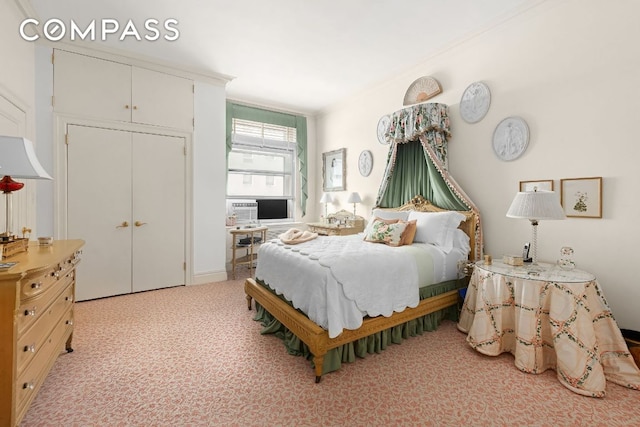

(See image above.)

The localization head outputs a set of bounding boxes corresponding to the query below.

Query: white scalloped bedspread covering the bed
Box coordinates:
[256,235,460,338]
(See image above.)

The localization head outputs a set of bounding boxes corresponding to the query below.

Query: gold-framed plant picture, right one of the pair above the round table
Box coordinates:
[560,177,602,218]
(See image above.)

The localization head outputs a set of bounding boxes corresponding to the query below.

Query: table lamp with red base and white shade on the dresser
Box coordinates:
[0,135,53,242]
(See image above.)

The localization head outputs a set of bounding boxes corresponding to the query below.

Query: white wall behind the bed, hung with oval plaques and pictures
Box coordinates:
[312,0,640,330]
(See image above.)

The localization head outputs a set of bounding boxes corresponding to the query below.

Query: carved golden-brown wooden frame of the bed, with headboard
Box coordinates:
[244,196,477,383]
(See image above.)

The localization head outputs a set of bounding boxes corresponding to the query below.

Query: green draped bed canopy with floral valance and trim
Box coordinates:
[376,103,482,256]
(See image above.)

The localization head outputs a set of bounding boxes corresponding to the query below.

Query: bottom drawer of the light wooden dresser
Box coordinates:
[14,306,73,419]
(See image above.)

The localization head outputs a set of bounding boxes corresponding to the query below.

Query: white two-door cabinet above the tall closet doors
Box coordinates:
[53,49,194,131]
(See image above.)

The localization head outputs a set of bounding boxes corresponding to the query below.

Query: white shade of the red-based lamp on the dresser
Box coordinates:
[0,136,53,179]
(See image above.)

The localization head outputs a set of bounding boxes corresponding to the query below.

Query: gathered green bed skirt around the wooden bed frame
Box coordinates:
[254,280,464,374]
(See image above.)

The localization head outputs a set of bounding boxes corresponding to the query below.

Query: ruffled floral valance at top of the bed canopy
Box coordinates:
[384,103,451,170]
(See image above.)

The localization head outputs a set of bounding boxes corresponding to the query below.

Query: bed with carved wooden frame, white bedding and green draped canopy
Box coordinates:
[245,103,482,382]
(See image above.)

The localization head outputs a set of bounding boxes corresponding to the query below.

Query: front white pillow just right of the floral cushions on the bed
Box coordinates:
[409,211,466,253]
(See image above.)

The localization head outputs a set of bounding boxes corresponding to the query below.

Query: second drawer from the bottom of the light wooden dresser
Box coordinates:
[16,282,74,375]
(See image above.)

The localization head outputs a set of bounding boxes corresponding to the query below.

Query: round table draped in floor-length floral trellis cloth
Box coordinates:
[458,261,640,397]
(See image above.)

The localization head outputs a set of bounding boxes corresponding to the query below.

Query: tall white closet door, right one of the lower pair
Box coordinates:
[132,133,186,292]
